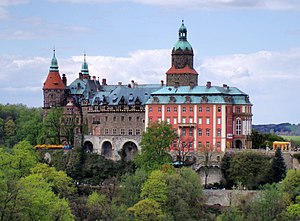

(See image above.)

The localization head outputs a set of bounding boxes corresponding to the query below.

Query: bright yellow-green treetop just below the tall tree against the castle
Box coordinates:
[141,170,168,205]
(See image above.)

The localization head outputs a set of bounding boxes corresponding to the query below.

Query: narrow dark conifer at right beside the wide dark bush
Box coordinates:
[271,148,286,183]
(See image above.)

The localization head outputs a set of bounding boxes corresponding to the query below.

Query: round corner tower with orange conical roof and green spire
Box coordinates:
[43,50,67,109]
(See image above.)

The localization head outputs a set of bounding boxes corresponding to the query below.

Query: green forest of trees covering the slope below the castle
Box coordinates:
[0,105,300,221]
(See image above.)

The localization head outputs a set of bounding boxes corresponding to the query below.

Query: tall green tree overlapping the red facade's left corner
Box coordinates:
[135,122,177,171]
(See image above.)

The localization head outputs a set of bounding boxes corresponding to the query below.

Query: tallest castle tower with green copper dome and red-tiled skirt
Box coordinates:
[166,20,198,87]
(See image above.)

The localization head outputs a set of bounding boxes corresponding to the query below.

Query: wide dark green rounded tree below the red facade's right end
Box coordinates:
[222,151,271,189]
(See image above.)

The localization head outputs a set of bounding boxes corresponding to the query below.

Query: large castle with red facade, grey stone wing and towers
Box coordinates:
[43,22,252,160]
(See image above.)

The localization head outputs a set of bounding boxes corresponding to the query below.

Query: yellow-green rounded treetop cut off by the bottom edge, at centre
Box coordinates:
[128,198,166,221]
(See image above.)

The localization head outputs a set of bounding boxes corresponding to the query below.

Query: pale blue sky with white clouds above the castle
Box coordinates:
[0,0,300,124]
